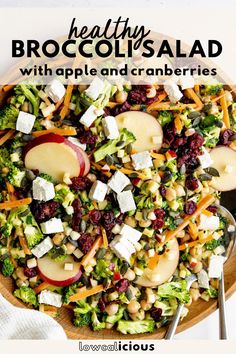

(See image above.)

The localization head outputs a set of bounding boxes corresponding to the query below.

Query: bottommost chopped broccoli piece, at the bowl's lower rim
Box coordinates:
[117,320,155,334]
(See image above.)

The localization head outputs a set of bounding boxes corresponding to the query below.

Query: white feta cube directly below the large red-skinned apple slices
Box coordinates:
[33,177,55,202]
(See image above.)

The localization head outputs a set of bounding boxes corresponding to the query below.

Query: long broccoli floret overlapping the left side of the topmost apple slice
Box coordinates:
[94,128,136,162]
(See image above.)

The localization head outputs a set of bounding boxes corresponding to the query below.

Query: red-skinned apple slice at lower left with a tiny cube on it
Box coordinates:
[38,256,82,286]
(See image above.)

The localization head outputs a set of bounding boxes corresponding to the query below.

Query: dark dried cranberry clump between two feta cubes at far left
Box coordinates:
[31,201,60,222]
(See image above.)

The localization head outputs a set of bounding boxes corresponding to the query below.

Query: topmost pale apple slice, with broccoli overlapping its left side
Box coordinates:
[116,111,163,152]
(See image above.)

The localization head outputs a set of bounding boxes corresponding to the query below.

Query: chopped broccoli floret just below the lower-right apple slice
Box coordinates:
[158,280,190,304]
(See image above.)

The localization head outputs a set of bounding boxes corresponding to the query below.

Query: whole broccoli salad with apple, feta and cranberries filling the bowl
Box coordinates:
[0,77,236,334]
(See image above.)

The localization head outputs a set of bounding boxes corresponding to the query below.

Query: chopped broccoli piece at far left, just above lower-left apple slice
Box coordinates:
[21,210,43,248]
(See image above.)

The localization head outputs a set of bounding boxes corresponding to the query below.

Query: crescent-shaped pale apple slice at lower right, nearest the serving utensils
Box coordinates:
[136,239,179,288]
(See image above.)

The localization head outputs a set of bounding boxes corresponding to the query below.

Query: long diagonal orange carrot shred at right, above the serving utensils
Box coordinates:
[162,195,215,244]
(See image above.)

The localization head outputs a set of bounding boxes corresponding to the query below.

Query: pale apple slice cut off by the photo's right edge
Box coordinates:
[210,146,236,192]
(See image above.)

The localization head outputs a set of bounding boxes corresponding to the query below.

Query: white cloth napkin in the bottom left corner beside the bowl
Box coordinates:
[0,294,67,339]
